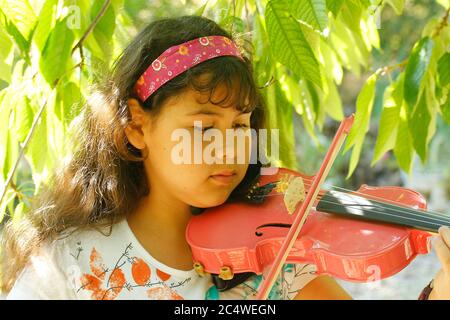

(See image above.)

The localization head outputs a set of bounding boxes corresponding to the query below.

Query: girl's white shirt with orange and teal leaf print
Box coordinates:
[7,219,316,300]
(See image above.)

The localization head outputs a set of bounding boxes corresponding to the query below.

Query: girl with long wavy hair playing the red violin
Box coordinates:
[1,16,450,299]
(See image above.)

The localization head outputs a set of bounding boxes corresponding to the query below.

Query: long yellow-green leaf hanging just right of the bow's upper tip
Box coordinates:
[344,73,377,179]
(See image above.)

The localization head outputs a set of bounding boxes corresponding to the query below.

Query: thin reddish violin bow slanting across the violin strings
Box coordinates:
[253,114,354,300]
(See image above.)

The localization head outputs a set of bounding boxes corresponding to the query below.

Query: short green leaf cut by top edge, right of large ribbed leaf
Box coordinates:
[291,0,328,31]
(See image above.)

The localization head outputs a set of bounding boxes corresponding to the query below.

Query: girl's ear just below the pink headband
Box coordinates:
[125,99,149,150]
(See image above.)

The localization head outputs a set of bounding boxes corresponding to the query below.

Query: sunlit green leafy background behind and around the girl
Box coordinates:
[0,0,450,297]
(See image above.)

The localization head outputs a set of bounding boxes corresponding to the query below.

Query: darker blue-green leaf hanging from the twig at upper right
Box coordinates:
[404,37,433,111]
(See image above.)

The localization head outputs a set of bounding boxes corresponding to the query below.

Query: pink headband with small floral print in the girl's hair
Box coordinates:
[134,36,243,101]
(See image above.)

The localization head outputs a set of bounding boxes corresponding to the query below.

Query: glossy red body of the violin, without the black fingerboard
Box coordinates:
[186,168,431,282]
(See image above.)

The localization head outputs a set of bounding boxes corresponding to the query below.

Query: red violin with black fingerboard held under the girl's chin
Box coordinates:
[186,114,450,298]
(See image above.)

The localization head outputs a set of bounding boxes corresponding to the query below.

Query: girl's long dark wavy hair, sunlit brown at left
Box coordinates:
[0,16,265,292]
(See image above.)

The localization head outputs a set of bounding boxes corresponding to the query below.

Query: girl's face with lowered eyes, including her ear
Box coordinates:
[126,81,251,208]
